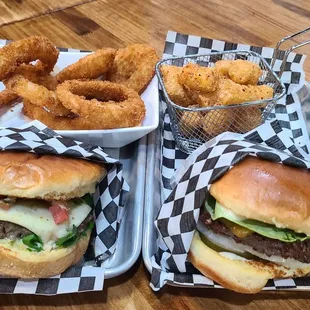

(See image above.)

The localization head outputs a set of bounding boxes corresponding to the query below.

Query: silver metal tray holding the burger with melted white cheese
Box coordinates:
[103,137,147,279]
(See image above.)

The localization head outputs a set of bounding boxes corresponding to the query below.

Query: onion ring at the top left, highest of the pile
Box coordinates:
[0,36,59,81]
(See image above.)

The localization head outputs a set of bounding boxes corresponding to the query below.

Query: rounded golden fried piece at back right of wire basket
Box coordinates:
[228,59,262,85]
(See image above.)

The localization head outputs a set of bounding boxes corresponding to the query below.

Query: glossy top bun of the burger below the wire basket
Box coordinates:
[210,156,310,235]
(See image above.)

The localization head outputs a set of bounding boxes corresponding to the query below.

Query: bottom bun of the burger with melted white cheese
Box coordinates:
[0,232,90,279]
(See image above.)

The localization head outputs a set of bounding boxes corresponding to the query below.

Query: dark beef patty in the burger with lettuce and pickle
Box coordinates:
[200,212,310,264]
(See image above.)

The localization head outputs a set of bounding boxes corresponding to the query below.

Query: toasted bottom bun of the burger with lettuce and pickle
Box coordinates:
[188,232,310,294]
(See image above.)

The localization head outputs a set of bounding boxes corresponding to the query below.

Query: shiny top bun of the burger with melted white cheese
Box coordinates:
[0,152,106,200]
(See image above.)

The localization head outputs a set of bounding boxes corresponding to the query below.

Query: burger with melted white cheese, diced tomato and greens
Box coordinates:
[0,151,106,278]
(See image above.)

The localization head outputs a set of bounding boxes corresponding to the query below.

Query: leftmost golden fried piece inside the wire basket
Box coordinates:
[160,65,193,107]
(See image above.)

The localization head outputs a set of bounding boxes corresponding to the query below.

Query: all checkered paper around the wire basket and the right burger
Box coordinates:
[151,31,310,290]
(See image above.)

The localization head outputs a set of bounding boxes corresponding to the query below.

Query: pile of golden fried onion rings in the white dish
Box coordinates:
[0,36,158,130]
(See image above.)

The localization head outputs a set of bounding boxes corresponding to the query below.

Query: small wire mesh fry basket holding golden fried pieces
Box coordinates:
[156,50,285,154]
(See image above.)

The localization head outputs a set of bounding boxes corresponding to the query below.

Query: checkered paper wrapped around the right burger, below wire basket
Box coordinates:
[151,120,310,290]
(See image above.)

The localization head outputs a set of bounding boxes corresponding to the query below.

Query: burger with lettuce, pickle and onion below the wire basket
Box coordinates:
[188,156,310,293]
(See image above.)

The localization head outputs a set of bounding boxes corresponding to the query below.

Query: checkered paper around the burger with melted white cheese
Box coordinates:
[0,121,129,295]
